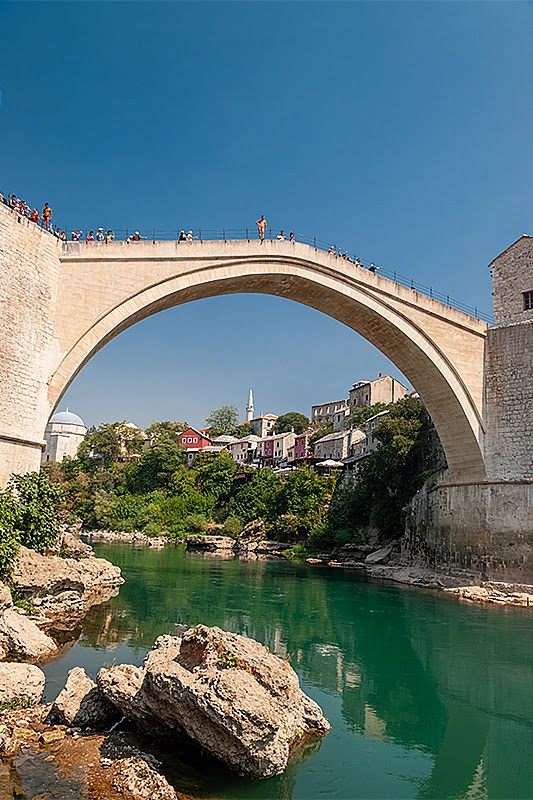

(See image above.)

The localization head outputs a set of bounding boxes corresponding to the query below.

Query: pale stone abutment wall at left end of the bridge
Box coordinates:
[0,204,60,486]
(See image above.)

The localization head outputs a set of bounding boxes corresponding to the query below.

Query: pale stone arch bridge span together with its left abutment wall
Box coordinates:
[0,207,532,580]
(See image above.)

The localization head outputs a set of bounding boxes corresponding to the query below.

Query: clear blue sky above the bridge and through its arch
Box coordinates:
[0,0,533,426]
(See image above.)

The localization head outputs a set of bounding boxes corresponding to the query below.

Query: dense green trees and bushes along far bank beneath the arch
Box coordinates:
[38,397,440,555]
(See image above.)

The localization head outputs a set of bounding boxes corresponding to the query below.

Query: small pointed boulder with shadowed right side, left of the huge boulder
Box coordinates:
[51,667,119,728]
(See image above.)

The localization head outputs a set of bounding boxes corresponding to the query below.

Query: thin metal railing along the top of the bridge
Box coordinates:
[0,195,493,324]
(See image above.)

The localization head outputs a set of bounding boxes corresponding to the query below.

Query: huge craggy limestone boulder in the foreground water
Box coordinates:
[97,625,330,778]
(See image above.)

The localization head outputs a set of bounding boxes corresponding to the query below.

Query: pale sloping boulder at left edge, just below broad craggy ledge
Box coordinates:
[0,584,57,658]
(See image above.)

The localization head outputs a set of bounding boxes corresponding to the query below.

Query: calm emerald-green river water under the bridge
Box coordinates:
[41,544,533,800]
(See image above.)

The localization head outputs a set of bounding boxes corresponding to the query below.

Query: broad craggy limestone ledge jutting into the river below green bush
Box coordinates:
[12,547,124,628]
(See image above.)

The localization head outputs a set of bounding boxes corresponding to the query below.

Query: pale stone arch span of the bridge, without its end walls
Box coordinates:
[52,241,487,480]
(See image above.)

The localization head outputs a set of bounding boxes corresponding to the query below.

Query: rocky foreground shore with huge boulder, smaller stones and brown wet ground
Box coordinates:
[0,625,330,800]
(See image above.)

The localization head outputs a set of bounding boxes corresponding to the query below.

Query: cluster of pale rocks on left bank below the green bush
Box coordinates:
[0,533,124,660]
